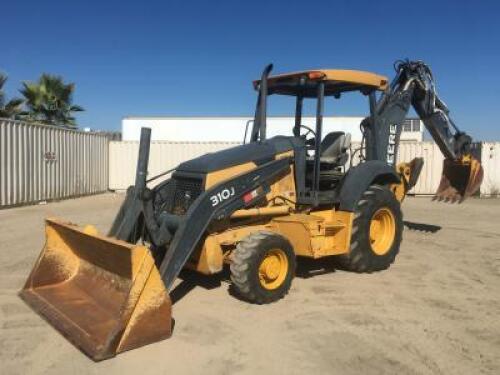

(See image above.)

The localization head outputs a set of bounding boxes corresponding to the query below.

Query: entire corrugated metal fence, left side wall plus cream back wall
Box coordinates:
[0,119,500,207]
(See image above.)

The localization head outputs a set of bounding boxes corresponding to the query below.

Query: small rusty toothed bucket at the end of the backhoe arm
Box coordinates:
[434,156,484,203]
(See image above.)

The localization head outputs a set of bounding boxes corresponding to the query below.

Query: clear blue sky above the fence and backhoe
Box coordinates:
[0,0,500,140]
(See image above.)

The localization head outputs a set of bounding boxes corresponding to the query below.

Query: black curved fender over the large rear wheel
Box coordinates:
[339,160,400,212]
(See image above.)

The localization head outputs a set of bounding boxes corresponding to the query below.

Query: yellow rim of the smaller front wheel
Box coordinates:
[259,249,288,290]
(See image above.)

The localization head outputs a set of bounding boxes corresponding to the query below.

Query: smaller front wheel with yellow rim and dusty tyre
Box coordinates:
[231,231,296,304]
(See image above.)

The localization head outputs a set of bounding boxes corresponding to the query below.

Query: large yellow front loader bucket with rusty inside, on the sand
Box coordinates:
[20,219,171,360]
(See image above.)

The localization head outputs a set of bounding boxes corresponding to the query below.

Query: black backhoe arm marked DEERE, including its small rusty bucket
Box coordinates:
[362,61,483,201]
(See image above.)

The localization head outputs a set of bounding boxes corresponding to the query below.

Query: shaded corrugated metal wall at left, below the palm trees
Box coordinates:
[0,119,108,207]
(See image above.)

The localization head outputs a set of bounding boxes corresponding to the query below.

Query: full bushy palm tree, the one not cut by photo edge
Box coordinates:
[20,73,84,129]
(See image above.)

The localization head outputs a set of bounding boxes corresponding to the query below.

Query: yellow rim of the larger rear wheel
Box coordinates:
[370,207,396,255]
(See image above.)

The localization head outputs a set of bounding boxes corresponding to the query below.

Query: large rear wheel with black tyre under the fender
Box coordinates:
[337,185,403,272]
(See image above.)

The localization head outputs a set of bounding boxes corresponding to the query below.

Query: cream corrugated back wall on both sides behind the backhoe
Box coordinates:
[109,141,500,196]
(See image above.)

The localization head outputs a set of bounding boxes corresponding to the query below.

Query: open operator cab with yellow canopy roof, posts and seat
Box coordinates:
[250,65,388,205]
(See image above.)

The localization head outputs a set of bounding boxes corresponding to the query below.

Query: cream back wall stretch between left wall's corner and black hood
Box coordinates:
[109,141,240,190]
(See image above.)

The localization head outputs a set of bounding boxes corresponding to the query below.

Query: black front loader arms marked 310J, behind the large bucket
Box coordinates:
[108,128,292,290]
